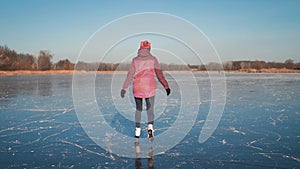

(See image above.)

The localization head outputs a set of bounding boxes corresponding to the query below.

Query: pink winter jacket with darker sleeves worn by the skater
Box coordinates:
[123,49,169,98]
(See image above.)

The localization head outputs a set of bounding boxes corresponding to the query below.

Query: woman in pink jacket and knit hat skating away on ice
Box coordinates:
[121,41,171,141]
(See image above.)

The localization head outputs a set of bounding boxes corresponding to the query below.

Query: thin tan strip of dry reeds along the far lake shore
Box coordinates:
[0,68,300,76]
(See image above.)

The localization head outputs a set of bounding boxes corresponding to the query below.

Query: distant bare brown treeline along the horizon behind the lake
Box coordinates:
[0,46,300,71]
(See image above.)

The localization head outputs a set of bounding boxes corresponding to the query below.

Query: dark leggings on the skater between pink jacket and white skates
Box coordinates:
[134,96,154,127]
